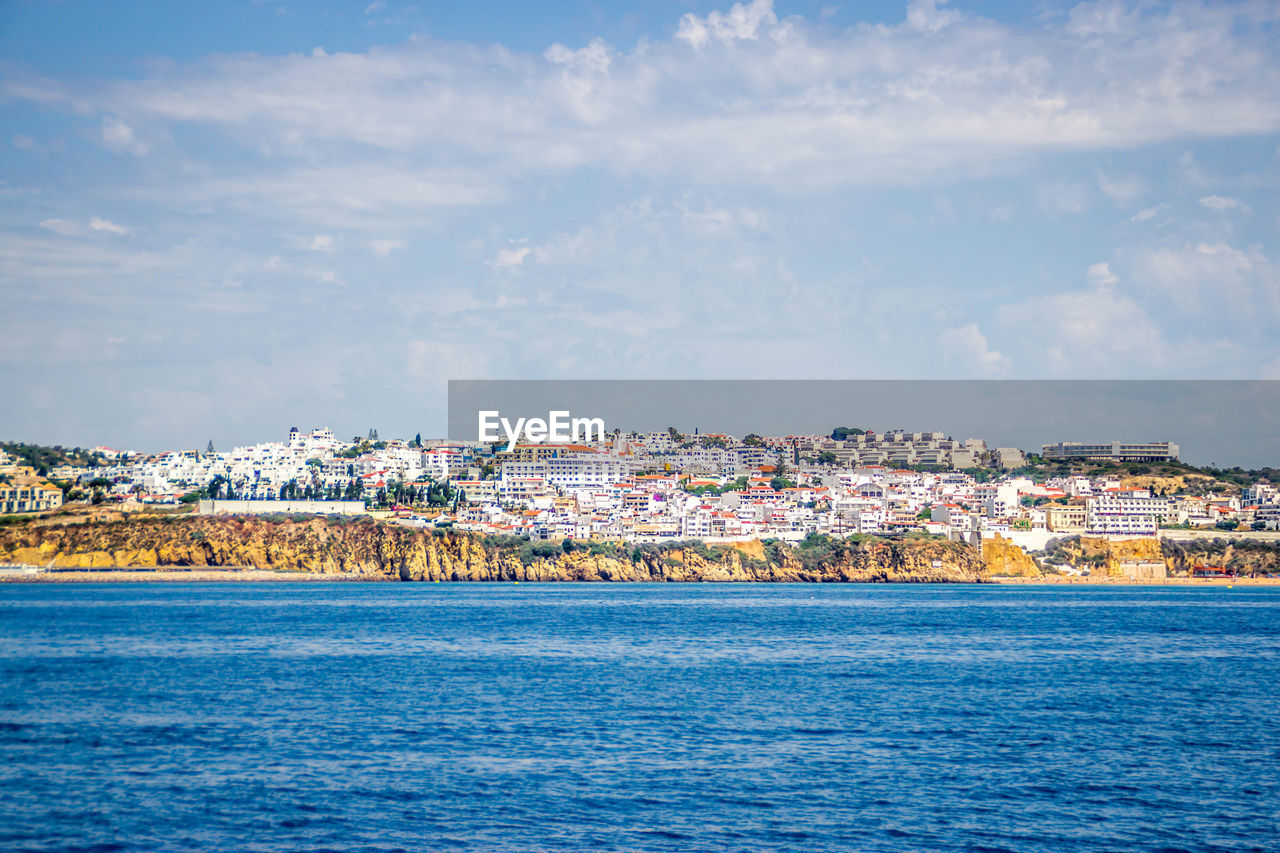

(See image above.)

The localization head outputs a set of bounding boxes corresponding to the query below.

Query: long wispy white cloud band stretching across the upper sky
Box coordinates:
[17,0,1280,194]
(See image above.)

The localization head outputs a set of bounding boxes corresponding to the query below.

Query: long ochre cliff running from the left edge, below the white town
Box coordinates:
[0,516,987,583]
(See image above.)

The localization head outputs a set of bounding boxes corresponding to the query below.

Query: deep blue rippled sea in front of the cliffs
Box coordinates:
[0,584,1280,852]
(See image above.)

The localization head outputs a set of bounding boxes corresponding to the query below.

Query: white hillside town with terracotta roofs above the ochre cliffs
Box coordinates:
[0,427,1280,563]
